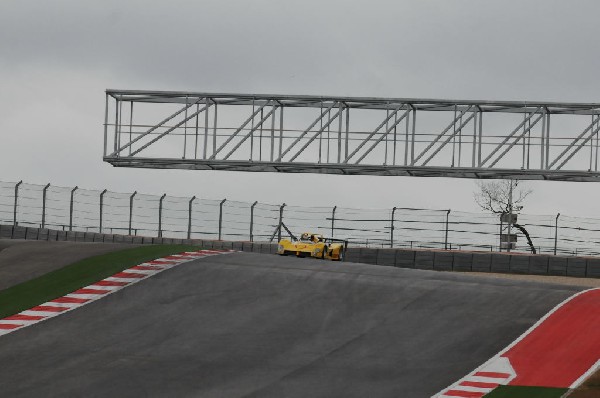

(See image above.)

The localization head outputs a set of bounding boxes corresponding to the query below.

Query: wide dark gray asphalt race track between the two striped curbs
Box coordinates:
[0,253,582,398]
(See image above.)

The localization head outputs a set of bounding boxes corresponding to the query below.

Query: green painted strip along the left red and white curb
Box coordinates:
[0,245,200,319]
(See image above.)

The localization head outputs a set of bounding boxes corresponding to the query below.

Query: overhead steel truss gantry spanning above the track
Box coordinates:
[104,90,600,181]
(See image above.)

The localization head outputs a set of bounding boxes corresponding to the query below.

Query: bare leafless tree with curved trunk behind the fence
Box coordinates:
[474,180,537,254]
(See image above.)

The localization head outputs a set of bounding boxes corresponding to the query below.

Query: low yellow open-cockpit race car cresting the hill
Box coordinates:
[277,232,347,261]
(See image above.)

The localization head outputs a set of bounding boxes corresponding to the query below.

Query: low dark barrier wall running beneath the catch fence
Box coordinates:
[0,225,600,278]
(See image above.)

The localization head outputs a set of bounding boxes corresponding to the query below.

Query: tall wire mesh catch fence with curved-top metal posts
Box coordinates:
[0,182,600,256]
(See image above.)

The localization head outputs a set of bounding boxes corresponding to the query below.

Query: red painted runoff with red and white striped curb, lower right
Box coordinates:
[433,289,600,398]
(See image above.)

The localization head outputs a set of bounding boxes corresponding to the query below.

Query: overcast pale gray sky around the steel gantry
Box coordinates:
[0,0,600,218]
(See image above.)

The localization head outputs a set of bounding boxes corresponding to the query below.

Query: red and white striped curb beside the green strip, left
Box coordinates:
[0,250,233,336]
